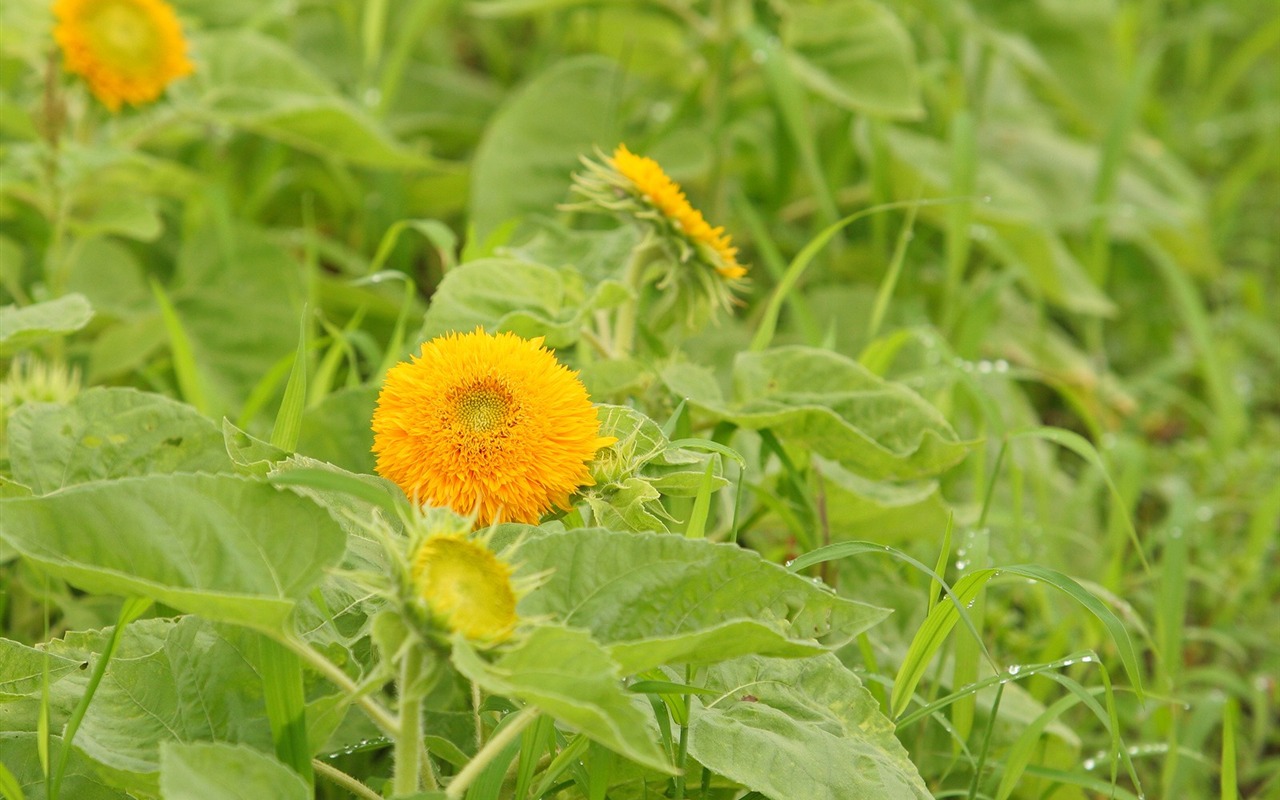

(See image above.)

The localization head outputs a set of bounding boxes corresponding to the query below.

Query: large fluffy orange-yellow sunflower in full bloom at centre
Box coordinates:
[374,328,614,525]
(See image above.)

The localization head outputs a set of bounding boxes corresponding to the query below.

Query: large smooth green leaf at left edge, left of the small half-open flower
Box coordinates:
[0,475,346,631]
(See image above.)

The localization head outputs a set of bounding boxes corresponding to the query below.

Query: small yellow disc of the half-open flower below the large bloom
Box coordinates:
[412,534,518,641]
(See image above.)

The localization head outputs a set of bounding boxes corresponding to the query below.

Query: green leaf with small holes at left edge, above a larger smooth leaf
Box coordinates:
[9,387,232,494]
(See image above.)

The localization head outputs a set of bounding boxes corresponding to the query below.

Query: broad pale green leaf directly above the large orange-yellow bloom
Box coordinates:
[421,259,627,347]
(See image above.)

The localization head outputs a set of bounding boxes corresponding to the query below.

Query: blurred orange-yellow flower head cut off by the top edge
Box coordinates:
[54,0,193,111]
